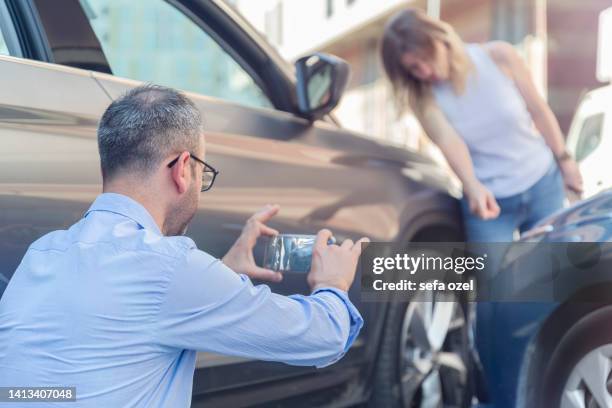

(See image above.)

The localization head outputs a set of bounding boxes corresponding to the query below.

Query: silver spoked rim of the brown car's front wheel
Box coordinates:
[400,292,467,408]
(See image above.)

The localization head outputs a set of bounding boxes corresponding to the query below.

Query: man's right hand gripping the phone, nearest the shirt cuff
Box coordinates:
[307,229,370,292]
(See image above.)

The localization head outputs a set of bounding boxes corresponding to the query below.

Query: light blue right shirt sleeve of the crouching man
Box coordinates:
[154,249,363,367]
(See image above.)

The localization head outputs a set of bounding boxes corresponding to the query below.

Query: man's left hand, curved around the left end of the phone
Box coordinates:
[223,204,283,282]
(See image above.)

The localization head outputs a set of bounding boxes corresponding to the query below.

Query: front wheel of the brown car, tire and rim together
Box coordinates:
[370,293,472,408]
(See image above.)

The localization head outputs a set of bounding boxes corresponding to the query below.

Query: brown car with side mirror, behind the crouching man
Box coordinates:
[0,0,467,407]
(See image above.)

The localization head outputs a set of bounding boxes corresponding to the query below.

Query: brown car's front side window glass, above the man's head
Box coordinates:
[80,0,272,108]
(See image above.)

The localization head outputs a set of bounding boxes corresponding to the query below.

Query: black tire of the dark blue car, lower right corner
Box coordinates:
[533,305,612,408]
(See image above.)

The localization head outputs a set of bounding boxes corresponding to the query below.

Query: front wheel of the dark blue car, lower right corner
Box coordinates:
[539,306,612,408]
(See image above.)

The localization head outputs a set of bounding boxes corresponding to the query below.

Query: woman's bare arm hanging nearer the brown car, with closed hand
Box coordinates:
[417,104,500,219]
